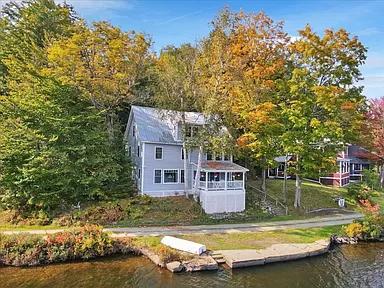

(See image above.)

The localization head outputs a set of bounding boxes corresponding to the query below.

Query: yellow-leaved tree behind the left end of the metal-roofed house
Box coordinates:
[48,21,152,138]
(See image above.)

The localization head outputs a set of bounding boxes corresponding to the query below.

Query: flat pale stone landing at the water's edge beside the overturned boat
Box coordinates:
[167,239,331,272]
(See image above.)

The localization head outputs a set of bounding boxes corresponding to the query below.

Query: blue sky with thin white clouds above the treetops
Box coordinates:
[0,0,384,98]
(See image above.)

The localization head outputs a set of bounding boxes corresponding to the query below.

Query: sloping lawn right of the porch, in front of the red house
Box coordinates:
[249,179,355,215]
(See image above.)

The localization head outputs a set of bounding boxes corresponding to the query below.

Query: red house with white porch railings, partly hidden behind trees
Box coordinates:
[268,145,370,187]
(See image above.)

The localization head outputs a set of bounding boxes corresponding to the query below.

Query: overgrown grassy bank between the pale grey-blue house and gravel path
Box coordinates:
[0,196,271,231]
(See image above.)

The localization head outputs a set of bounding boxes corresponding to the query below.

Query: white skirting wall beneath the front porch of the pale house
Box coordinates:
[200,190,245,214]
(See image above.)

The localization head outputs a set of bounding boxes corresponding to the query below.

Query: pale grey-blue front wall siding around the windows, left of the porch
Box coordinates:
[142,143,197,197]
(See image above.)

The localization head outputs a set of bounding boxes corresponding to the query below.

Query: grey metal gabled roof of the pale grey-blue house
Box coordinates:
[128,106,204,144]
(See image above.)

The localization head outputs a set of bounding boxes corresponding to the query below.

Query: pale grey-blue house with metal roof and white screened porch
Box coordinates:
[124,106,248,213]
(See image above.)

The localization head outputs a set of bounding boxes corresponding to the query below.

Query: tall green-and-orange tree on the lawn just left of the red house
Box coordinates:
[280,25,366,207]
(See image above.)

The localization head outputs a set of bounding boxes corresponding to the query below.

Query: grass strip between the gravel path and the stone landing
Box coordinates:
[180,226,342,250]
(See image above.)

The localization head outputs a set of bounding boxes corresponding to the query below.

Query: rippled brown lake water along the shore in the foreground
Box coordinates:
[0,243,384,288]
